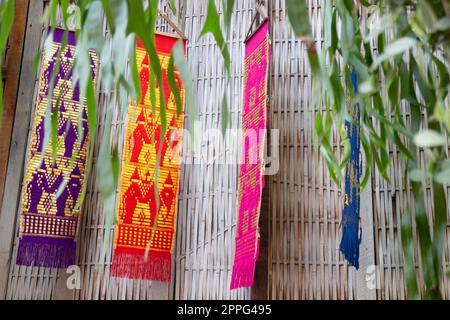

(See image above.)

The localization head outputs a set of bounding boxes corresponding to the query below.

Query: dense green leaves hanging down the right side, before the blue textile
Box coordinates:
[286,0,450,299]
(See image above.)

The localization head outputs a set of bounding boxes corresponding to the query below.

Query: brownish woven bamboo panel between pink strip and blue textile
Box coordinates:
[269,0,356,299]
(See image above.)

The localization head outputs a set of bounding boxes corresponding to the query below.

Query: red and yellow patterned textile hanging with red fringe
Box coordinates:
[111,34,186,282]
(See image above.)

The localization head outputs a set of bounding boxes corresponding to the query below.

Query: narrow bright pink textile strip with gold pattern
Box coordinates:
[230,20,270,289]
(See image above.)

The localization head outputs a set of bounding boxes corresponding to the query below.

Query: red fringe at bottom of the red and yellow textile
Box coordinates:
[111,252,172,282]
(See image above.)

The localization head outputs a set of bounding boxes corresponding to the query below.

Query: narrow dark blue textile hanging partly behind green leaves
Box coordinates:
[339,72,361,269]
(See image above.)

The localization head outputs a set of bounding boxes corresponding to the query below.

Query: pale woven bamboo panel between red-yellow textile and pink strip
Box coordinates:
[175,0,255,299]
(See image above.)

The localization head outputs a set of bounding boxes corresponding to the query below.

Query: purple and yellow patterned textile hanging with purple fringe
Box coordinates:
[16,29,97,268]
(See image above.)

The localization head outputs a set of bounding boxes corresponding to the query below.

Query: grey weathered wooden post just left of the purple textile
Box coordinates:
[0,1,44,299]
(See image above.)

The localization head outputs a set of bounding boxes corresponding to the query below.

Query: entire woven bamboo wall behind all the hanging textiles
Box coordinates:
[0,0,450,299]
